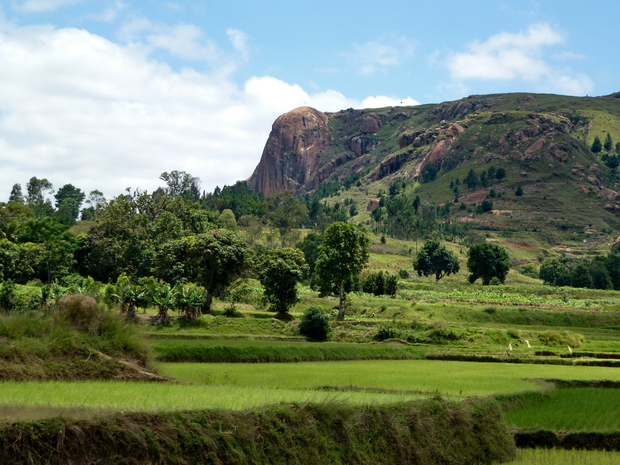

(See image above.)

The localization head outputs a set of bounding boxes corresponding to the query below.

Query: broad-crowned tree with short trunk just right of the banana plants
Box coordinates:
[153,230,251,311]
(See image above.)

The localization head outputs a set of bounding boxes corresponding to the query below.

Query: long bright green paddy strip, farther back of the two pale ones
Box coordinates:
[160,360,620,396]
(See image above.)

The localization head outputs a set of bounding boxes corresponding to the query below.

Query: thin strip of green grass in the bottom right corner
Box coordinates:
[494,449,620,465]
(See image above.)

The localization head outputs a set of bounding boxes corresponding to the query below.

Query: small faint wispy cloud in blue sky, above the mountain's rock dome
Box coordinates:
[347,36,415,75]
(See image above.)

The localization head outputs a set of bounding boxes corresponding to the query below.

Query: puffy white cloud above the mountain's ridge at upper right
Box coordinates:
[447,23,593,94]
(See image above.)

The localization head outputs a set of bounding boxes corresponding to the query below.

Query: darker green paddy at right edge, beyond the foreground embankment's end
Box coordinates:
[506,388,620,432]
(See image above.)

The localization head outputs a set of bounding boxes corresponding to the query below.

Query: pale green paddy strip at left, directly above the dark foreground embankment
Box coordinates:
[0,381,423,419]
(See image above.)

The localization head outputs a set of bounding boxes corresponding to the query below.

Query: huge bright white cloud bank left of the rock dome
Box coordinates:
[0,25,422,200]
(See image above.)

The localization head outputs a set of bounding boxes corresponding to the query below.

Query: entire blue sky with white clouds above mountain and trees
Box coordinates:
[0,0,620,201]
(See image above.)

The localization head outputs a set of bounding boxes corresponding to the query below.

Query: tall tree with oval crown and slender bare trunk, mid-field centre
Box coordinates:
[316,222,370,319]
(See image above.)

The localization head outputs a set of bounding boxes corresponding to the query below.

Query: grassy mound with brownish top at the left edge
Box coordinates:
[0,294,164,381]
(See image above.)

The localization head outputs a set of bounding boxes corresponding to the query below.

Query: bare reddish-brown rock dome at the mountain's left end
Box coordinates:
[248,107,332,197]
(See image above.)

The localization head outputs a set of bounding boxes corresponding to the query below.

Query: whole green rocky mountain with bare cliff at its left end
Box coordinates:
[248,93,620,234]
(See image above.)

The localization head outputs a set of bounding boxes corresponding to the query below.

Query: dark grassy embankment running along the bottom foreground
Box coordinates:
[0,398,515,465]
